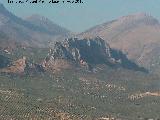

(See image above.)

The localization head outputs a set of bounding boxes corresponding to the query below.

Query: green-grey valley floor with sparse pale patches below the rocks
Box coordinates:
[0,68,160,120]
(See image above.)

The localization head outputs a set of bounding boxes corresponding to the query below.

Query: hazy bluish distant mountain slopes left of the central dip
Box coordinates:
[0,4,70,47]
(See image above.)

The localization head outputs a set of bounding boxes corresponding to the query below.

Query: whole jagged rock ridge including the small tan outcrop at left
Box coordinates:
[0,37,145,74]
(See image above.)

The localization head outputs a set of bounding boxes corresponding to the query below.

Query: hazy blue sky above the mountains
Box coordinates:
[0,0,160,32]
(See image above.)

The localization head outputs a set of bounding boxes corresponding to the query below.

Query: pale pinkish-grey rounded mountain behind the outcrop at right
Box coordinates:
[79,13,160,73]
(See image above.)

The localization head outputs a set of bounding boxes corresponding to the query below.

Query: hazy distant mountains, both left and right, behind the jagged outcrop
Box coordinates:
[0,4,160,72]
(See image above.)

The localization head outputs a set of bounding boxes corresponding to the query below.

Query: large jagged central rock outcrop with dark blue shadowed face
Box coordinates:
[43,37,144,71]
